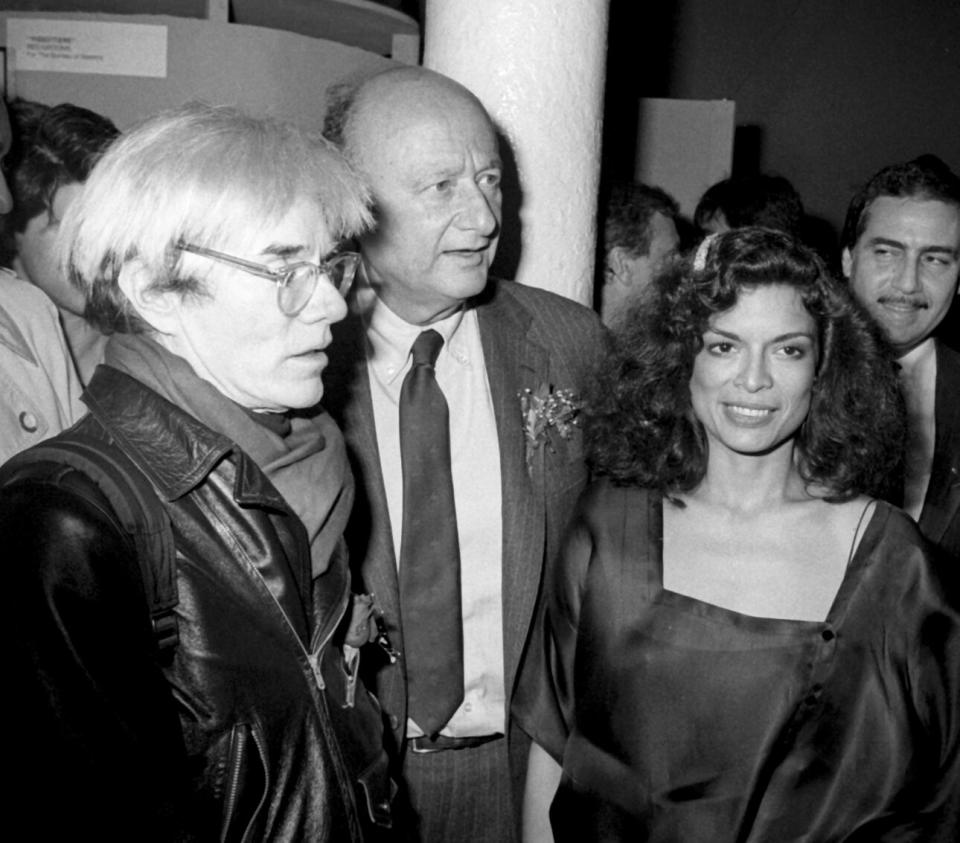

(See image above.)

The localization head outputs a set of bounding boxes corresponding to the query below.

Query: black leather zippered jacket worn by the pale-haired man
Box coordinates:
[0,366,385,843]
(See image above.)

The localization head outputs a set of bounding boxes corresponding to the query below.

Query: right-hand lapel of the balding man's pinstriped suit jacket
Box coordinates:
[477,292,549,700]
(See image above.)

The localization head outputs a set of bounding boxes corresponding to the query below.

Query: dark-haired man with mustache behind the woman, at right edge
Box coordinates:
[842,155,960,559]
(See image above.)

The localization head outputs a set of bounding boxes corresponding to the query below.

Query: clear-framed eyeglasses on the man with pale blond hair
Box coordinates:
[177,243,360,316]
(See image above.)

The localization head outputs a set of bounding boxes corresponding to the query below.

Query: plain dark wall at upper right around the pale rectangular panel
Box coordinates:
[604,0,960,241]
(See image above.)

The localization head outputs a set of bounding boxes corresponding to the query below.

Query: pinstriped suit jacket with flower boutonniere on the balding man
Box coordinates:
[323,280,604,788]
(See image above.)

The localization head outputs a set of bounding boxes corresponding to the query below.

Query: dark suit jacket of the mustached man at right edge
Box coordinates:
[920,342,960,562]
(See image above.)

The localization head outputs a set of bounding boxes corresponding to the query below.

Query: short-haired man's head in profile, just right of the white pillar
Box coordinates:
[599,182,680,327]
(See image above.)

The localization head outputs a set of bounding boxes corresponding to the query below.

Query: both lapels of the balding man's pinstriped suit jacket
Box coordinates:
[324,291,550,711]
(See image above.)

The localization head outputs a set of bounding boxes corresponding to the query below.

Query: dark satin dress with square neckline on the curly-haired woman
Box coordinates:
[514,482,960,843]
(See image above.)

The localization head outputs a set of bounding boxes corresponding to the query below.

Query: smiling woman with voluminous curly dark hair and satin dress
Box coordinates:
[515,228,960,843]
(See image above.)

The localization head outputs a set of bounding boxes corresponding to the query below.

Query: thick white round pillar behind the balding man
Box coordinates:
[424,0,609,304]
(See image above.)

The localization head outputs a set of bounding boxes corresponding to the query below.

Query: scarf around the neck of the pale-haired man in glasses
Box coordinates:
[104,334,353,577]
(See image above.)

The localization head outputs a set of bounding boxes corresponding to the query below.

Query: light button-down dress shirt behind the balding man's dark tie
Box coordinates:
[357,287,506,737]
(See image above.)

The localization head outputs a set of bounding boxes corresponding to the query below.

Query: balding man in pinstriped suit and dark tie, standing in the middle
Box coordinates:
[324,68,602,843]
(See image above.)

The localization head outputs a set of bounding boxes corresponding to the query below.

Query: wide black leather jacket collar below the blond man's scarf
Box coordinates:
[82,366,286,510]
